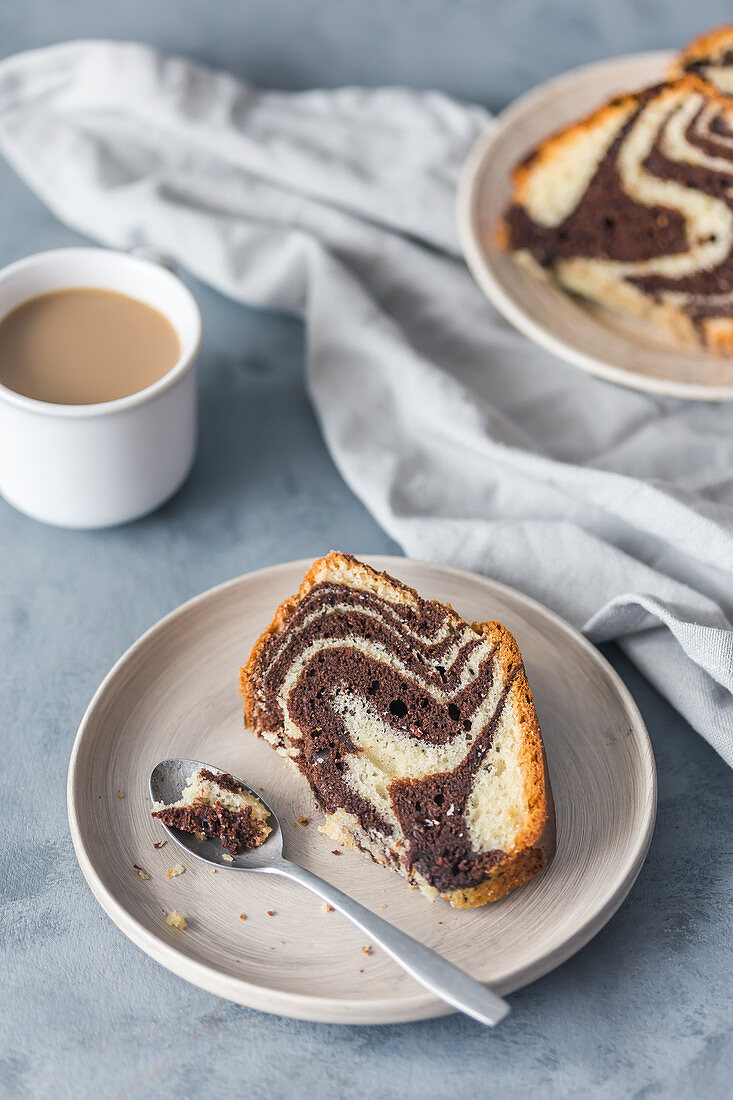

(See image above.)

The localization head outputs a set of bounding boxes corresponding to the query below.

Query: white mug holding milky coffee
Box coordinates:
[0,249,201,528]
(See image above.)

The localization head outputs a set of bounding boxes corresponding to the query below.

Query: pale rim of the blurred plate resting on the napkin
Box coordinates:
[455,50,733,402]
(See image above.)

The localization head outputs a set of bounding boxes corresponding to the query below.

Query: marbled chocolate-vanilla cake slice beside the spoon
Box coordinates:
[241,553,551,905]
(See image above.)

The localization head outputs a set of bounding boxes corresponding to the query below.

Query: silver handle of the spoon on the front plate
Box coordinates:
[263,859,510,1027]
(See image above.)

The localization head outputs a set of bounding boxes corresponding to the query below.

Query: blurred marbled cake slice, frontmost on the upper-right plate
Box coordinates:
[500,75,733,354]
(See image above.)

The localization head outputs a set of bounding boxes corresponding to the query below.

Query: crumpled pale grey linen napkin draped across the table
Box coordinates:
[0,42,733,765]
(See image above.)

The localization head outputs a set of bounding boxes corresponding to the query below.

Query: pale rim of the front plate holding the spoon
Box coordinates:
[66,554,657,1025]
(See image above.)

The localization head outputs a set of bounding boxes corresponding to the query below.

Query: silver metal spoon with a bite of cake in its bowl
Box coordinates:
[150,759,510,1027]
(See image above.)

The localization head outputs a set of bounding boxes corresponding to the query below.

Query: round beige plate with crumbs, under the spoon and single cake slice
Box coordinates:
[68,558,656,1024]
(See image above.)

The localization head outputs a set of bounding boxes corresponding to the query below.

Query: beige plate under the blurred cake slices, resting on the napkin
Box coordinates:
[457,53,733,402]
